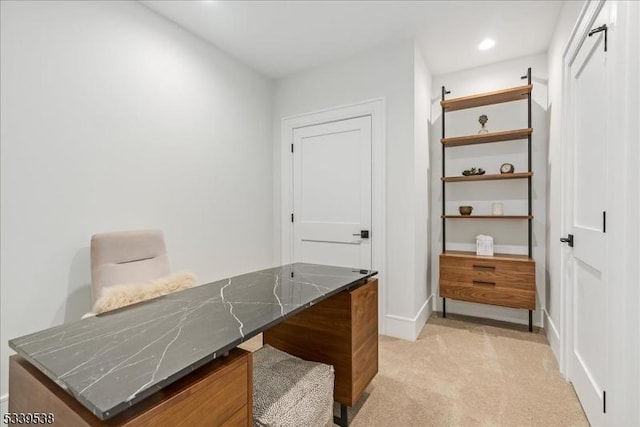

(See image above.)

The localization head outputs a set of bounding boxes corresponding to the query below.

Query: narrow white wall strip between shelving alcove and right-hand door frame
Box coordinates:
[544,1,584,365]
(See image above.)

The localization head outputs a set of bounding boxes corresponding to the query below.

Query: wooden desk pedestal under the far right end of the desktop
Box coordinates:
[263,279,378,406]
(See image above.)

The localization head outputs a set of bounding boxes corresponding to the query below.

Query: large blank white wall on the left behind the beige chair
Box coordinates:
[0,1,275,408]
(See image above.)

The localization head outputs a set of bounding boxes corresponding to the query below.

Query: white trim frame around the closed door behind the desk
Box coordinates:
[280,98,387,334]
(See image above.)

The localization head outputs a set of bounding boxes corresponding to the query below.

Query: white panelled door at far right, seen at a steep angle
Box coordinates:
[565,2,611,425]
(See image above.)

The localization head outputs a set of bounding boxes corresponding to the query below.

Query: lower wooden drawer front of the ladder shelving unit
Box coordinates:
[440,278,536,310]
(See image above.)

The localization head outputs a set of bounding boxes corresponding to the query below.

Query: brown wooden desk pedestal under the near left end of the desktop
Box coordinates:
[9,348,253,427]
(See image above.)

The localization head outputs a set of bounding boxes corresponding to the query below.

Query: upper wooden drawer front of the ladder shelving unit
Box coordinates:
[440,256,536,291]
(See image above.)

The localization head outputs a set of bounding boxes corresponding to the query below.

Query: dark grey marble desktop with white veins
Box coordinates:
[9,263,377,420]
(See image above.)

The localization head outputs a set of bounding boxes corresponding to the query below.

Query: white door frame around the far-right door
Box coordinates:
[554,0,640,425]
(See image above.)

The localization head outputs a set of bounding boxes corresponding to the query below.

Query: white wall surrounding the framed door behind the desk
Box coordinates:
[274,40,428,339]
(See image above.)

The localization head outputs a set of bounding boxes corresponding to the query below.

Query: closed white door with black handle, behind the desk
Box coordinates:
[292,116,375,269]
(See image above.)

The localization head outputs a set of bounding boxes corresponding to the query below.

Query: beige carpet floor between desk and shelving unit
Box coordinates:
[245,314,589,427]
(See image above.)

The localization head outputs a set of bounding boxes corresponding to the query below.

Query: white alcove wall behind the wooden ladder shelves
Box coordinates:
[430,54,548,324]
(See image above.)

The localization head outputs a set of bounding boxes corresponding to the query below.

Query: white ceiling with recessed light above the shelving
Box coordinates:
[142,0,563,78]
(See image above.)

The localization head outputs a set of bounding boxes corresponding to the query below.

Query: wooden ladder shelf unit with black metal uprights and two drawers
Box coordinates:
[440,68,536,331]
